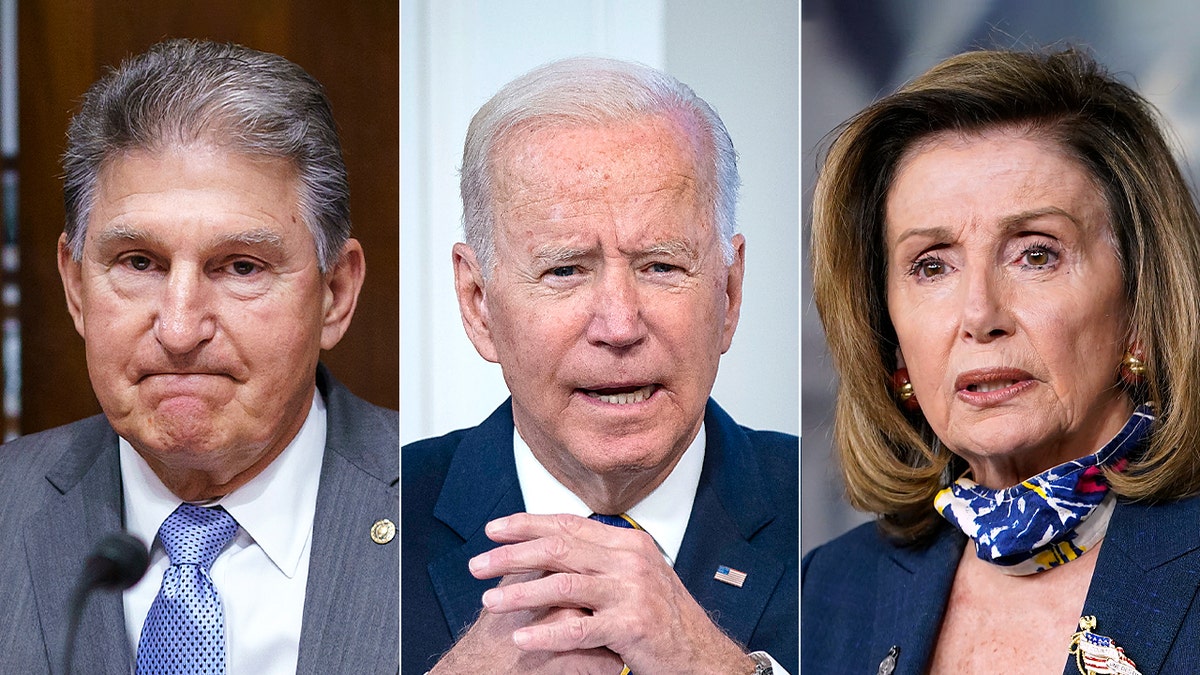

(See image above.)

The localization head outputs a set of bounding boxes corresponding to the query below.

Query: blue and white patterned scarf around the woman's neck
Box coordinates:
[934,405,1154,575]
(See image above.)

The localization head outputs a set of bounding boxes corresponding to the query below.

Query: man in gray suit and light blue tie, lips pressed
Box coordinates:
[0,40,400,675]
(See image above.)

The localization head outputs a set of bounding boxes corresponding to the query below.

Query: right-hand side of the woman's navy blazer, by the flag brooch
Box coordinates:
[1063,497,1200,675]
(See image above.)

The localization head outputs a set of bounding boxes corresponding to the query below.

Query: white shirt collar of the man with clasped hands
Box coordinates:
[512,423,706,566]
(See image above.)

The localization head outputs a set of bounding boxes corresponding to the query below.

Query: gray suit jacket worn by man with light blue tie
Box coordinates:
[0,368,400,675]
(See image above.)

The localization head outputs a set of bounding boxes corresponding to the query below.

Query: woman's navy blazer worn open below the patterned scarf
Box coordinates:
[800,497,1200,675]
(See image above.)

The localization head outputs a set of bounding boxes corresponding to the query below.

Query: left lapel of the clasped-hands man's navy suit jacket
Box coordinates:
[428,400,524,635]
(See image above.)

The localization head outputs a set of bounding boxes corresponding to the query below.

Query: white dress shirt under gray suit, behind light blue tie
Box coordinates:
[120,392,325,675]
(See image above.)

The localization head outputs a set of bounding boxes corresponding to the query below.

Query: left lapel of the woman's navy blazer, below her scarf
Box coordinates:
[869,526,966,675]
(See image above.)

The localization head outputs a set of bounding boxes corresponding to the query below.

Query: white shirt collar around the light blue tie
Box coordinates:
[119,392,326,578]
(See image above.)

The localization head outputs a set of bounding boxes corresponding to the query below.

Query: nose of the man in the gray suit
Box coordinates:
[154,265,216,354]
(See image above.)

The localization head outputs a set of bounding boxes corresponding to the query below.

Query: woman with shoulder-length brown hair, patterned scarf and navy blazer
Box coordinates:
[802,50,1200,675]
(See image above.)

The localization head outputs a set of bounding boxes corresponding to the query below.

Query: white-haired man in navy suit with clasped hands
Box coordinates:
[401,59,799,675]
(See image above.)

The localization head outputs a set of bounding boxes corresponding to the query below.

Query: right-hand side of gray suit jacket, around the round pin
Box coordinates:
[296,368,400,674]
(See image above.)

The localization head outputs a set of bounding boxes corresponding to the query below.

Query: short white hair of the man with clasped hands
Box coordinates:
[460,56,740,277]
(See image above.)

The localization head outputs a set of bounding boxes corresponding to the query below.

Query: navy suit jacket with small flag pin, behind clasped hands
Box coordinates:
[401,400,799,675]
